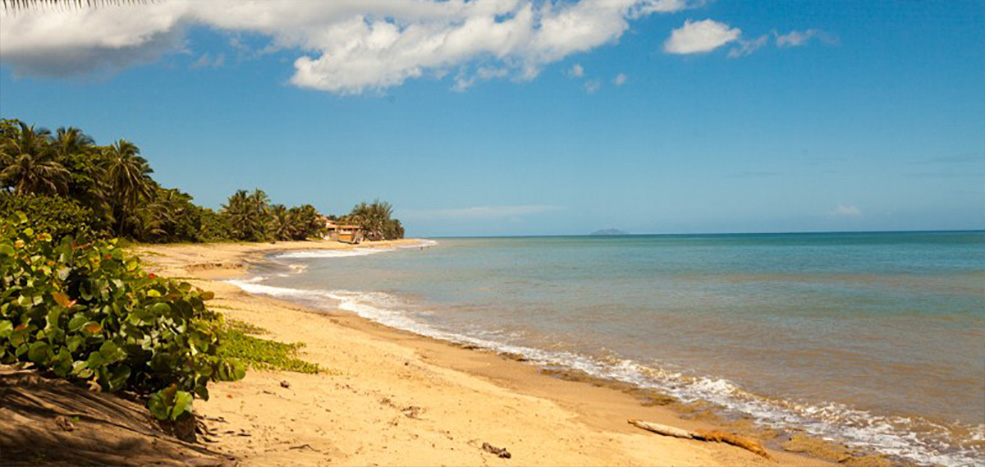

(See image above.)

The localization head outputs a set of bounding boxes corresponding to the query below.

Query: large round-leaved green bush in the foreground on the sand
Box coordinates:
[0,213,245,420]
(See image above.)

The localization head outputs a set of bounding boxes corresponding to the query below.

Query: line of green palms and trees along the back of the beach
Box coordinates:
[0,119,404,243]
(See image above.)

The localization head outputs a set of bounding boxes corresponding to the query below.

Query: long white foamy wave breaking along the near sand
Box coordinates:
[228,277,985,466]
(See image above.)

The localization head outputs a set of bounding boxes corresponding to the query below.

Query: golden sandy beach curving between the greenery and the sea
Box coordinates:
[135,240,830,466]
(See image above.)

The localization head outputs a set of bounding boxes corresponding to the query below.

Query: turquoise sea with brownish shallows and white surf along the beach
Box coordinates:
[238,232,985,465]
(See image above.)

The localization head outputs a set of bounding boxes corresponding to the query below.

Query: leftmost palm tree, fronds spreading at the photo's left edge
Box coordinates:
[0,123,69,195]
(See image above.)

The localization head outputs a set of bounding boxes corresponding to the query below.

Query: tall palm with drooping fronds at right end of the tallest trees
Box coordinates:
[105,139,157,235]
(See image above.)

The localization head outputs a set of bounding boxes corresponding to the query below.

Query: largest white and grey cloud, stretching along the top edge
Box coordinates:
[0,0,693,94]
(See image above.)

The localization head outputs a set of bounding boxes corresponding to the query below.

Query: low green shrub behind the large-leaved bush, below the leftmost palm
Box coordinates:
[0,192,100,238]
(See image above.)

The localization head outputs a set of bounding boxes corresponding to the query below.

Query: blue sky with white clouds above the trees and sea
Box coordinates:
[0,0,985,236]
